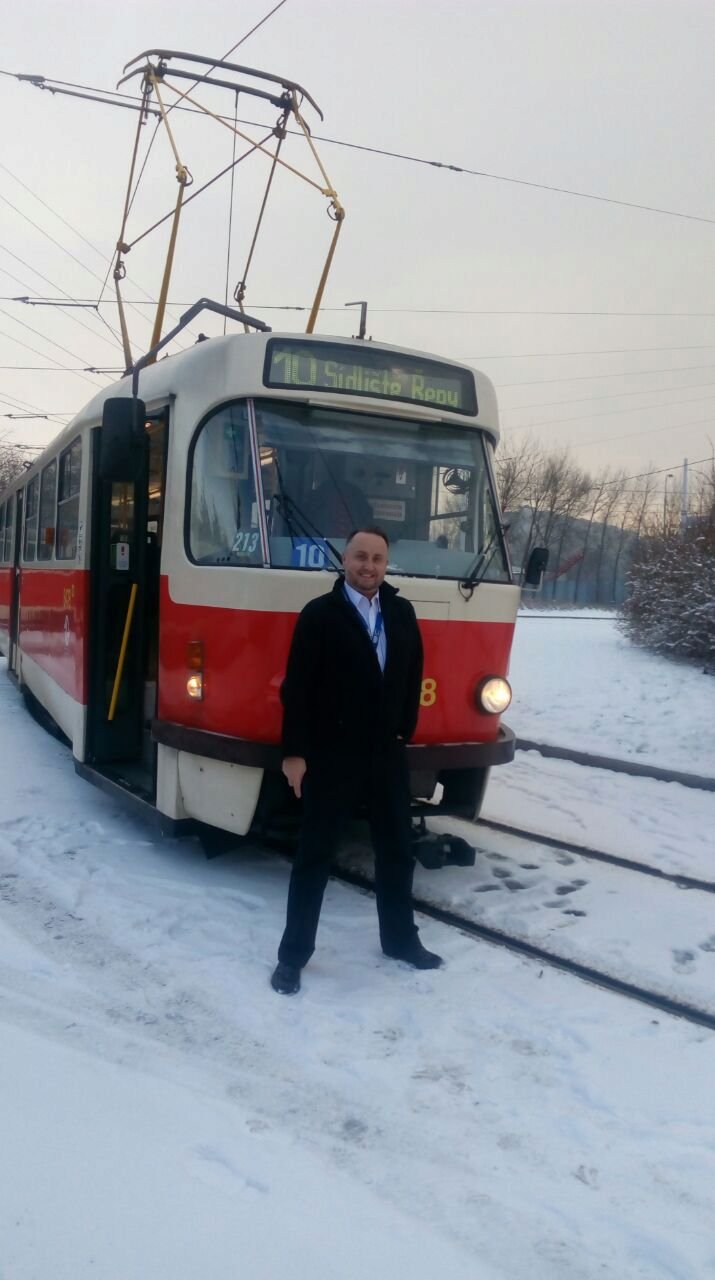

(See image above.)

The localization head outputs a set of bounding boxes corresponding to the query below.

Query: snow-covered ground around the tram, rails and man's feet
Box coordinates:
[0,620,715,1280]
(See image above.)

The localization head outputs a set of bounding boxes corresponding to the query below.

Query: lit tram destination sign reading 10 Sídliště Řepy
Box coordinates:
[263,338,477,417]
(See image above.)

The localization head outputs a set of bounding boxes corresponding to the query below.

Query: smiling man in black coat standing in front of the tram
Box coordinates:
[271,527,441,996]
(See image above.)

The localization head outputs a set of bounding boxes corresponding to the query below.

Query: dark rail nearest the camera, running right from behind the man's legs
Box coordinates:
[333,868,715,1032]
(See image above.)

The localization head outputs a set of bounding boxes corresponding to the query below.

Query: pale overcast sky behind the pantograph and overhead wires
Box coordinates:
[0,0,715,499]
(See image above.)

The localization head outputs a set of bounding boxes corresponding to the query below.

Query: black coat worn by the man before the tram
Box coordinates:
[280,576,422,760]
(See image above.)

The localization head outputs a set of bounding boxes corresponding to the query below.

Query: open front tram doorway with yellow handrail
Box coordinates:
[87,399,166,795]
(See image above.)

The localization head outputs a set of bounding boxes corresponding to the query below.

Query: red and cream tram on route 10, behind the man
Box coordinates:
[0,320,537,835]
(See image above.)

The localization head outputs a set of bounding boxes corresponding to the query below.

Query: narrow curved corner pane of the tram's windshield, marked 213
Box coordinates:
[189,404,262,564]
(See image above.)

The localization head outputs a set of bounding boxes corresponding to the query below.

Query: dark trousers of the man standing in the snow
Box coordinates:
[278,742,417,969]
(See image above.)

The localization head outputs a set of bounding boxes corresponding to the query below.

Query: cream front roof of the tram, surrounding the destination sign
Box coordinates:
[8,332,499,492]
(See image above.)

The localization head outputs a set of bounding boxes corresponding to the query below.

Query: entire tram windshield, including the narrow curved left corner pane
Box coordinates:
[189,401,510,582]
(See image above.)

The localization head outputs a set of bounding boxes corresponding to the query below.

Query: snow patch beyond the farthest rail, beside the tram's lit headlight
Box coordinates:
[508,609,715,777]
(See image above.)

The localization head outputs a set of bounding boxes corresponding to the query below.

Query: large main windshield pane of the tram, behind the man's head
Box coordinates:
[256,401,510,582]
